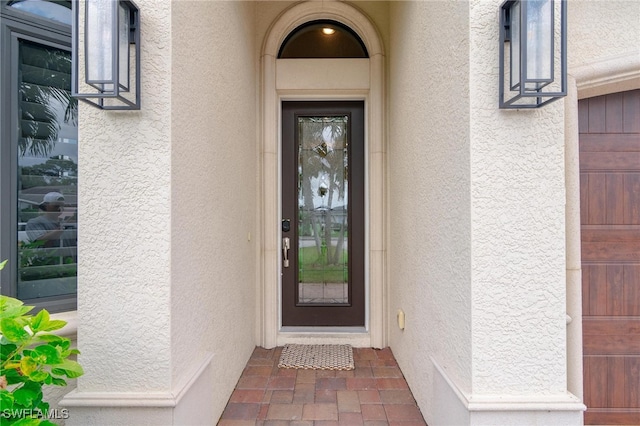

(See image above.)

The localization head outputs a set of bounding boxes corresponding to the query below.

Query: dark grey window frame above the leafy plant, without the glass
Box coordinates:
[0,0,77,313]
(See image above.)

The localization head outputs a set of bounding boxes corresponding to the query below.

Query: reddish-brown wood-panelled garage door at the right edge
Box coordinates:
[579,90,640,425]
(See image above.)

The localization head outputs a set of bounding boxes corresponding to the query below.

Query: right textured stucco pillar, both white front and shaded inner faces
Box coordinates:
[388,1,580,422]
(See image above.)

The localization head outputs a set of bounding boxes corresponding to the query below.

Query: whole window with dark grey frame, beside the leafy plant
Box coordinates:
[0,0,78,312]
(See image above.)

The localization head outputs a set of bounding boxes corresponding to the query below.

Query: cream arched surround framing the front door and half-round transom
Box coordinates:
[256,2,387,348]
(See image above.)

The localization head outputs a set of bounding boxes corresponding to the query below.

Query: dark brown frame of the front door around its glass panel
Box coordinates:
[281,101,366,327]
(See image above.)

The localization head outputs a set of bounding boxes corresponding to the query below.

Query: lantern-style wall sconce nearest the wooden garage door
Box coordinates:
[499,0,567,109]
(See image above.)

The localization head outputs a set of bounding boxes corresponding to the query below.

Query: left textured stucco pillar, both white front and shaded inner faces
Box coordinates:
[69,0,258,424]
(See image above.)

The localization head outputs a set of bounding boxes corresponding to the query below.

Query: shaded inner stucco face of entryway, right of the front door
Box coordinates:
[388,2,472,423]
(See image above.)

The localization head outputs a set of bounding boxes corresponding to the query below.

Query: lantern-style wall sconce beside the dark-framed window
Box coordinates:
[71,0,140,110]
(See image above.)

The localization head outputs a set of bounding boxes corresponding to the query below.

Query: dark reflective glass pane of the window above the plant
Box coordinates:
[17,40,78,300]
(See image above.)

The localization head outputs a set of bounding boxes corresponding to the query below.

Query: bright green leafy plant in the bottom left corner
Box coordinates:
[0,261,84,426]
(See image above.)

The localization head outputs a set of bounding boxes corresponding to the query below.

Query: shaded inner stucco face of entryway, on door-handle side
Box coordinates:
[171,1,259,415]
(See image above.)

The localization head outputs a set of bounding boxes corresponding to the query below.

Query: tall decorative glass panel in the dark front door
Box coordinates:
[297,116,350,305]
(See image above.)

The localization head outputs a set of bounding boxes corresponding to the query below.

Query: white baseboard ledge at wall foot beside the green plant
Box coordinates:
[60,353,213,408]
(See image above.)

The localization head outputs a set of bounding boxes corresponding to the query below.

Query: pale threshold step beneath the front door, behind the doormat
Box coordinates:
[276,326,371,348]
